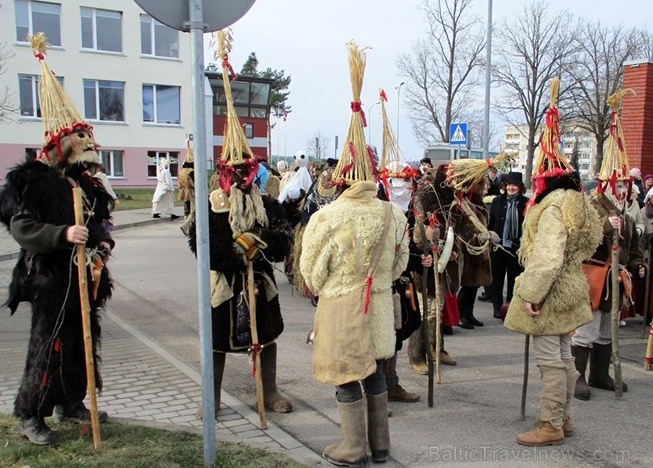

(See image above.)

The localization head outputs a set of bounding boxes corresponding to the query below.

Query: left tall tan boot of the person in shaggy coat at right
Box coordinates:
[517,362,567,447]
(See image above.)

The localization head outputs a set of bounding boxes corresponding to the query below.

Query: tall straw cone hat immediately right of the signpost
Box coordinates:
[213,28,254,166]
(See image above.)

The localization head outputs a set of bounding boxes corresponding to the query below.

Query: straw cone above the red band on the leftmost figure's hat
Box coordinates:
[27,32,86,146]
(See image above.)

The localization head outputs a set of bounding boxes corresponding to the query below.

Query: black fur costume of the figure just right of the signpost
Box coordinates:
[188,195,292,352]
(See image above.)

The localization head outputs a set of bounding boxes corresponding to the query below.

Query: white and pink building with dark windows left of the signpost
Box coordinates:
[0,0,193,187]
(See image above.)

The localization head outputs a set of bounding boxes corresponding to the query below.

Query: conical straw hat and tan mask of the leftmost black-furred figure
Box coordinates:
[28,32,100,168]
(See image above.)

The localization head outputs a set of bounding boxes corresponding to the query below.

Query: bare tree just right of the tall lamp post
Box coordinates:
[492,0,575,186]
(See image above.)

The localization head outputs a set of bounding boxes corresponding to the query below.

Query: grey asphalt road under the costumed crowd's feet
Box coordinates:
[111,224,653,466]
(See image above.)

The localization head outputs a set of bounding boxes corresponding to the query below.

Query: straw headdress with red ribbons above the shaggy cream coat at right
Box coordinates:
[531,78,574,200]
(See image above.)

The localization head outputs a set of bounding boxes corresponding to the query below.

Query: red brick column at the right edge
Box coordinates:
[621,60,653,176]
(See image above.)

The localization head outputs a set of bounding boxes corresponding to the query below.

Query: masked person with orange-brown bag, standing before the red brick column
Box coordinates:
[571,91,646,400]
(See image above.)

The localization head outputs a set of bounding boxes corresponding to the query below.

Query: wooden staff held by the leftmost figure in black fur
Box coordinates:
[73,187,101,450]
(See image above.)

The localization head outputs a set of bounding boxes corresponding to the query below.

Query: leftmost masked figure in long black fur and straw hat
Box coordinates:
[0,33,114,445]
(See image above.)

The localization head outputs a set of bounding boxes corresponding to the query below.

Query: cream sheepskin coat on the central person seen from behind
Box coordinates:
[300,182,408,360]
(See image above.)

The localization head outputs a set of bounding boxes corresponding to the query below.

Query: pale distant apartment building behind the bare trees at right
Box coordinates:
[503,124,596,179]
